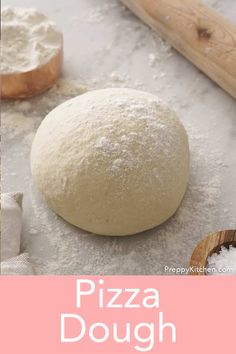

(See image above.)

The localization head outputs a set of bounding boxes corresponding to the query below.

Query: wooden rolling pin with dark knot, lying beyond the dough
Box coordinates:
[122,0,236,98]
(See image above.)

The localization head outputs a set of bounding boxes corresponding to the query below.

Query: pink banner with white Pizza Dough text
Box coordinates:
[0,276,236,354]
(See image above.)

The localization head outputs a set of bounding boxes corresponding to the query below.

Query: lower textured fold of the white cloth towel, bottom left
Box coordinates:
[1,253,34,275]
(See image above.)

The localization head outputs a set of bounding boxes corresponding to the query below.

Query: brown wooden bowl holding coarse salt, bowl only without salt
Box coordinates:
[189,230,236,275]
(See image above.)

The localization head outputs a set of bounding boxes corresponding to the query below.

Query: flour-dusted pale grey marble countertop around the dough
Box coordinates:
[2,0,236,274]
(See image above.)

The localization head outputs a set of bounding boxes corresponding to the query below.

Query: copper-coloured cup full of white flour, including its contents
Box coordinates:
[1,7,63,99]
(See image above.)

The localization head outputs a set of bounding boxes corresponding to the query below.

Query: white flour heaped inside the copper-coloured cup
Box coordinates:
[0,7,62,74]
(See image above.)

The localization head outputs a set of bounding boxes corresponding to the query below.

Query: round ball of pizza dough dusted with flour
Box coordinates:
[31,88,189,236]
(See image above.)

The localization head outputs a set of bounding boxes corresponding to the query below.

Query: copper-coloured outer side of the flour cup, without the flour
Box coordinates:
[1,40,63,99]
